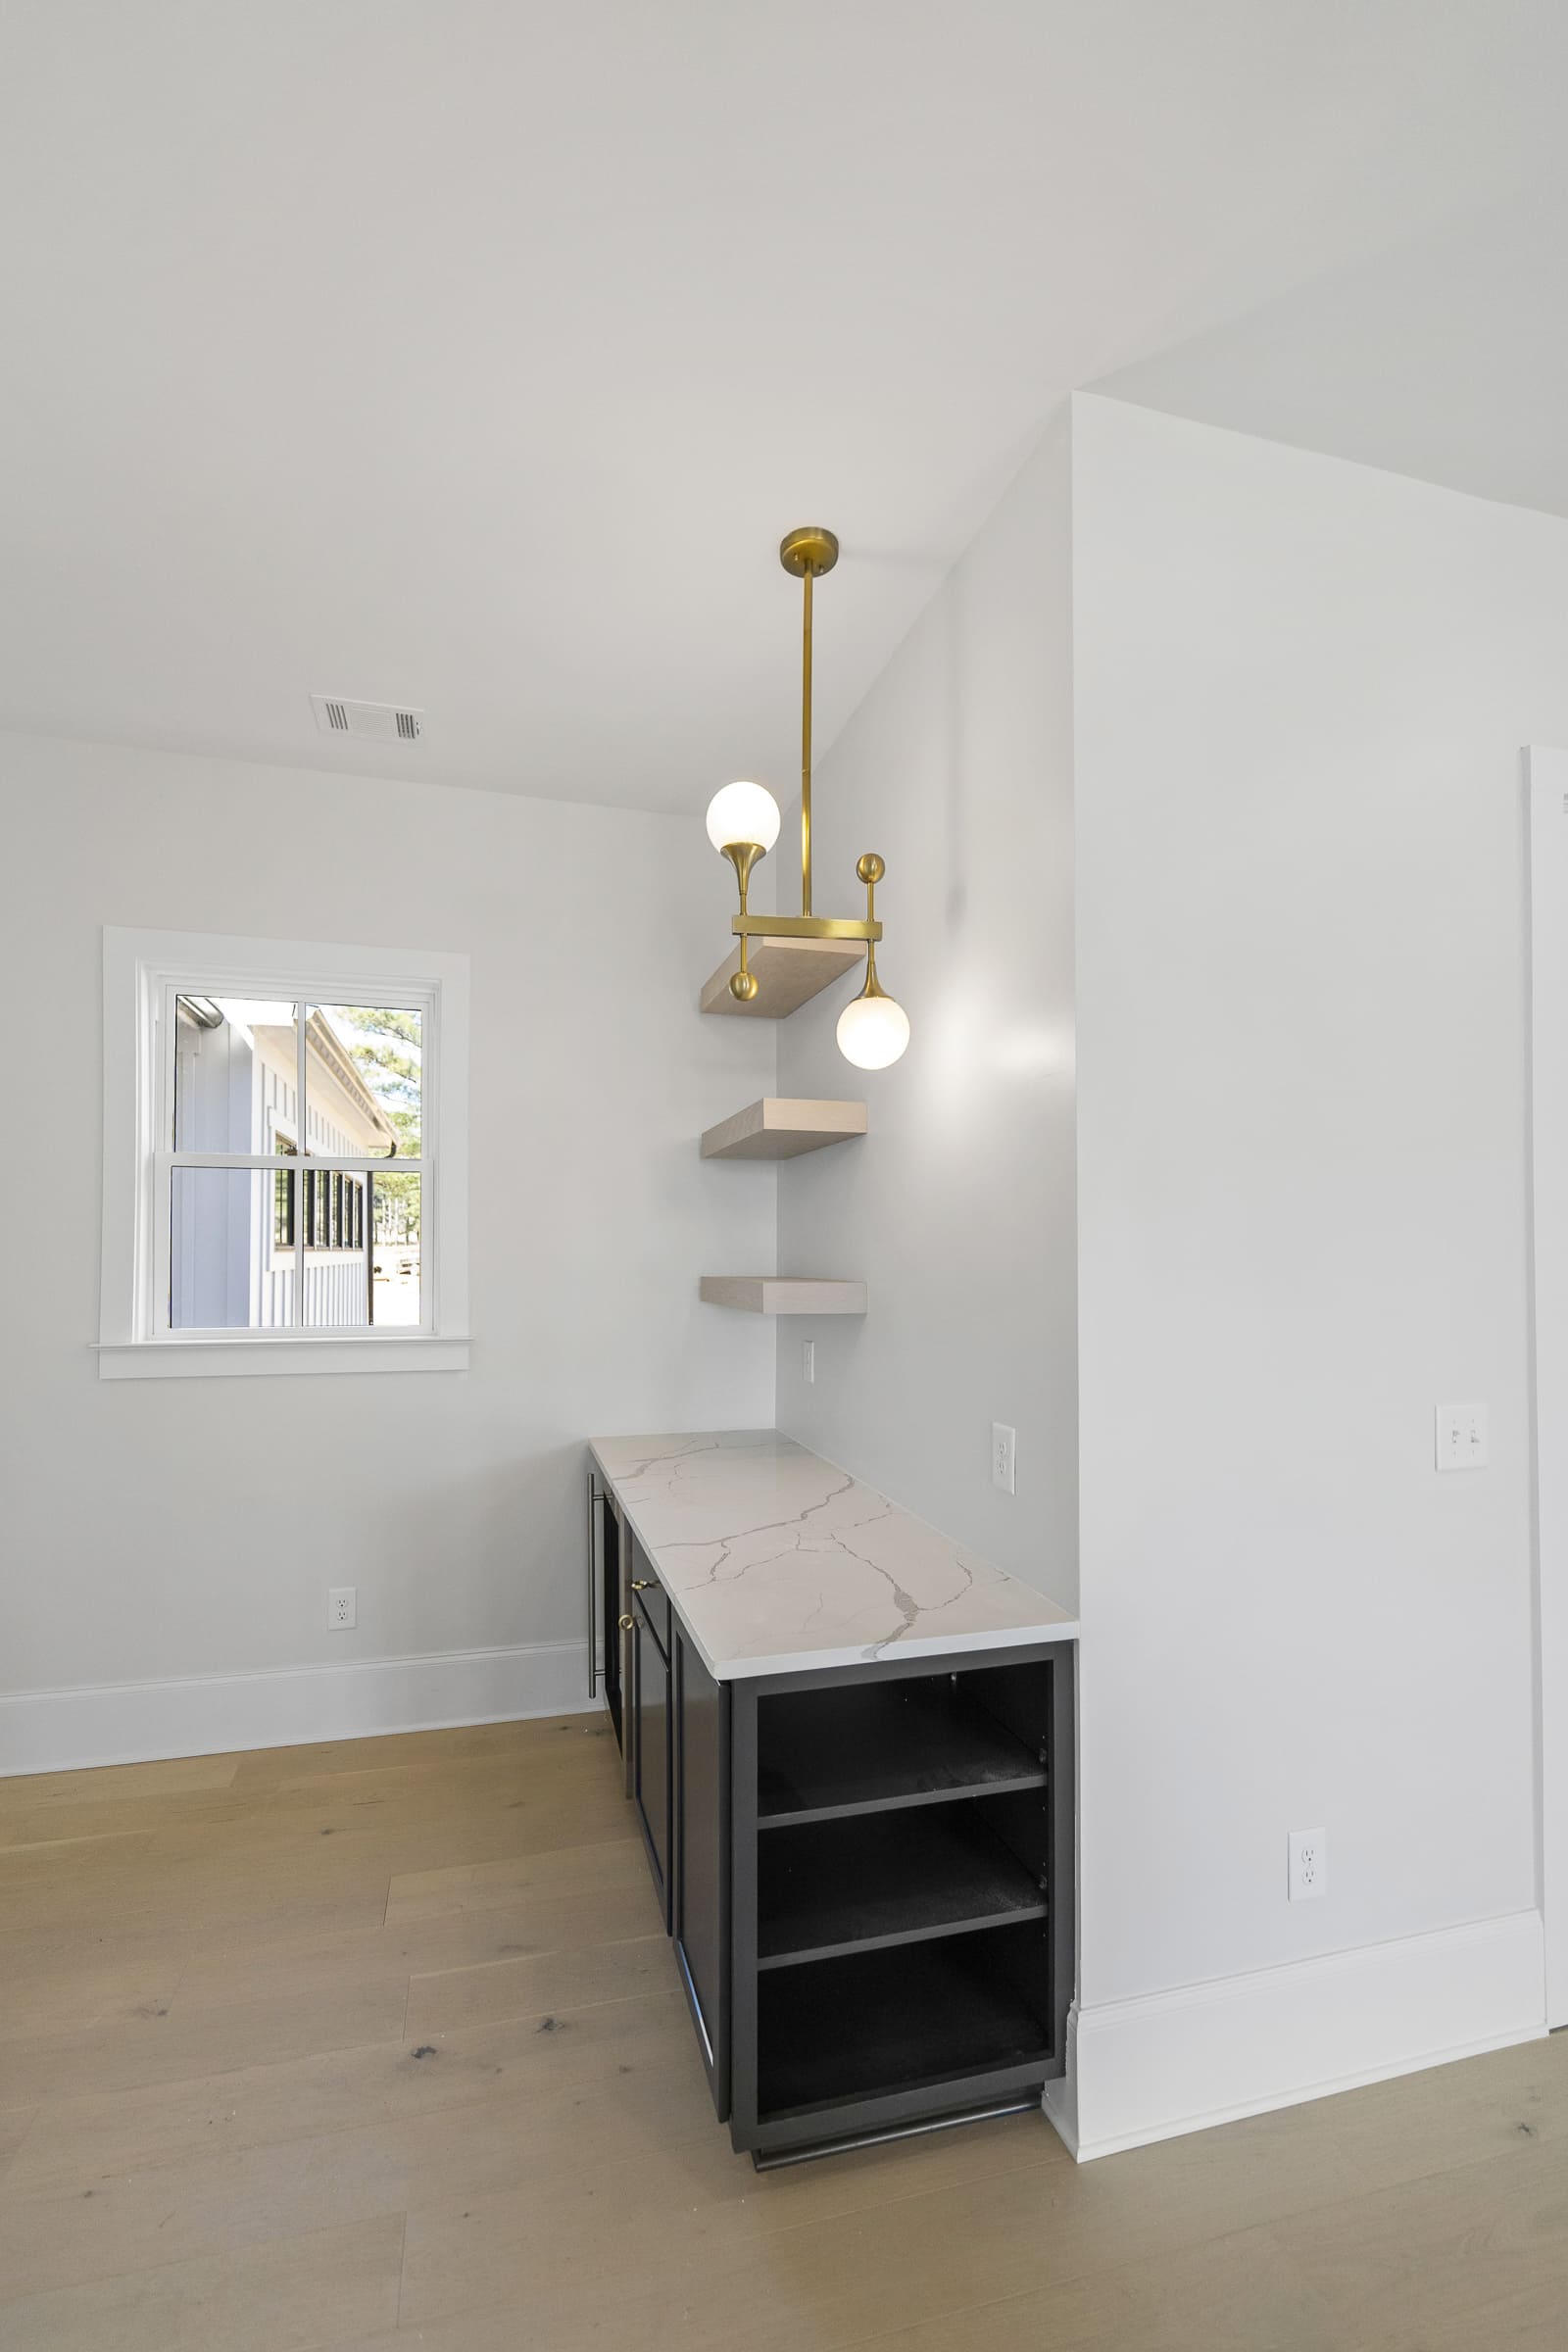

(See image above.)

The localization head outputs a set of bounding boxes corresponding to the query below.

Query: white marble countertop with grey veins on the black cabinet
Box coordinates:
[590,1430,1079,1682]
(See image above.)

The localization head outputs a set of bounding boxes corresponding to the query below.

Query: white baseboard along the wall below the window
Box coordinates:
[0,1642,592,1776]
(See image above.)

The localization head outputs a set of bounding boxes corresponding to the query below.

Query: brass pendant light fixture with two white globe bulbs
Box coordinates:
[708,527,909,1070]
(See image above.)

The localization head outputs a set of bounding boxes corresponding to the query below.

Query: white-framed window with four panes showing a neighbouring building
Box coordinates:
[99,931,467,1378]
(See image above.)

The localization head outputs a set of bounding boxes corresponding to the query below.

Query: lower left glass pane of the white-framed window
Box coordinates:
[170,1169,294,1331]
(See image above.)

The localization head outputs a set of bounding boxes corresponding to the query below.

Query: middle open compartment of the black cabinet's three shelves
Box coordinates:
[757,1804,1046,1969]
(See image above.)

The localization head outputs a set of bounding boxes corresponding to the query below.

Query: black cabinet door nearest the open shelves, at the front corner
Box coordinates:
[670,1628,729,2124]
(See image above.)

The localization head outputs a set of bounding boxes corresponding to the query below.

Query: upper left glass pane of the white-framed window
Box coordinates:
[174,995,299,1152]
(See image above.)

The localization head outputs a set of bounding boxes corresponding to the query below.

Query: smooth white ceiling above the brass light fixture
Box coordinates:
[0,0,1568,811]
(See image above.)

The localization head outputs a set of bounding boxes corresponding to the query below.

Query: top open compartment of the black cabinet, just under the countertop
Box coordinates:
[757,1677,1046,1830]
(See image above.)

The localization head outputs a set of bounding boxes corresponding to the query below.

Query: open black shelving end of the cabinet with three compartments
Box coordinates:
[731,1648,1072,2164]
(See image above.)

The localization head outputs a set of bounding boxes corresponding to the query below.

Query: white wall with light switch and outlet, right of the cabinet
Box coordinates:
[1074,398,1568,2145]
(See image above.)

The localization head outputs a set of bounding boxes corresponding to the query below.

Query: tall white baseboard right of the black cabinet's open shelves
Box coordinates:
[1046,1910,1546,2164]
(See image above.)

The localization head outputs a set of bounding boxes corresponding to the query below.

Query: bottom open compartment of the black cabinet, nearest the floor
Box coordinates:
[757,1927,1051,2122]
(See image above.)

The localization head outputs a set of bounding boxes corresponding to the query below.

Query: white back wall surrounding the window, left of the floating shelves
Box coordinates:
[0,736,773,1771]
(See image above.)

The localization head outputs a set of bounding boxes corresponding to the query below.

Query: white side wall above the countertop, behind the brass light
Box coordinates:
[778,416,1077,1606]
